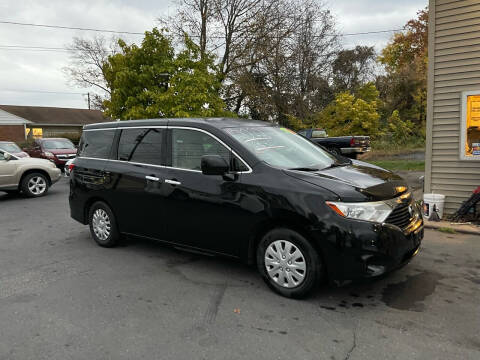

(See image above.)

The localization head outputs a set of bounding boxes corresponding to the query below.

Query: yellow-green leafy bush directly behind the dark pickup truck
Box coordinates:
[317,83,381,137]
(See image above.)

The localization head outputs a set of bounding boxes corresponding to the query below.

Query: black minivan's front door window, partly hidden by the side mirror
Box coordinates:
[172,129,230,170]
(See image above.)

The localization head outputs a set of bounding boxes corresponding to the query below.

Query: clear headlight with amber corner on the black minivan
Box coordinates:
[327,201,393,223]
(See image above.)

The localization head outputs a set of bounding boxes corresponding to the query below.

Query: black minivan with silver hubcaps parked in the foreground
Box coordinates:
[69,118,423,298]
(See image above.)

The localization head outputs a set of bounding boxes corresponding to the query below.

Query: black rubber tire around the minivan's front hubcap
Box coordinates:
[257,228,324,299]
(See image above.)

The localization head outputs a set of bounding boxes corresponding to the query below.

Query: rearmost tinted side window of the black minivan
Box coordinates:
[78,130,115,159]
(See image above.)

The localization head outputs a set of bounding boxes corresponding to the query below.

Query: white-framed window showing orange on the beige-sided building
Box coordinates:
[460,90,480,160]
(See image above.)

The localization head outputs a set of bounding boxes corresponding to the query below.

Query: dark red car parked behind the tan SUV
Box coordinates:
[24,138,77,170]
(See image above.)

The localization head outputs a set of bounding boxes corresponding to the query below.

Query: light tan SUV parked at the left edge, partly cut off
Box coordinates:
[0,150,61,197]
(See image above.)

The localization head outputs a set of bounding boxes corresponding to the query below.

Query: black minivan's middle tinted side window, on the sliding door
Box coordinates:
[118,128,164,165]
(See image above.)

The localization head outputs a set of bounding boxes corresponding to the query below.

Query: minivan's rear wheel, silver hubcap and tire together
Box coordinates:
[88,201,120,247]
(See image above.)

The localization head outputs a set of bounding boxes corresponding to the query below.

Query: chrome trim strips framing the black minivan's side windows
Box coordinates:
[77,125,253,174]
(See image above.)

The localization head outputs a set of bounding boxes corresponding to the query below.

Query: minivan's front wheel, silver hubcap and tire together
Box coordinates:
[257,228,323,298]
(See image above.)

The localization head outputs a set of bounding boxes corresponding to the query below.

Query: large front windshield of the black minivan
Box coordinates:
[225,126,336,170]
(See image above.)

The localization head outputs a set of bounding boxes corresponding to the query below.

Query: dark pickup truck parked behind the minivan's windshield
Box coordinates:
[298,129,371,159]
